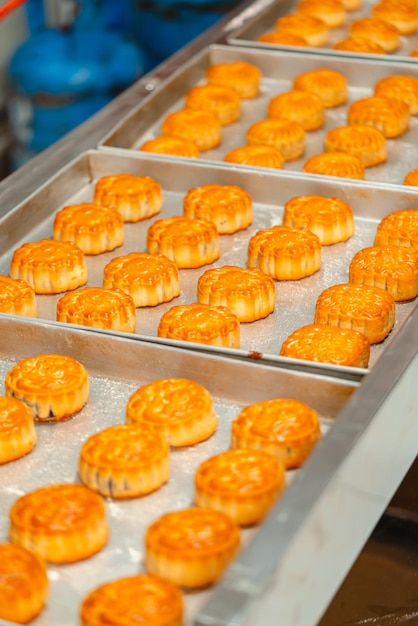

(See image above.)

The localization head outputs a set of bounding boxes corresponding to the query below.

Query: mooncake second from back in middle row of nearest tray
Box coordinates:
[78,424,170,498]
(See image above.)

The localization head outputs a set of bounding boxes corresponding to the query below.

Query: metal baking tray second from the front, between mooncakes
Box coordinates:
[0,150,418,377]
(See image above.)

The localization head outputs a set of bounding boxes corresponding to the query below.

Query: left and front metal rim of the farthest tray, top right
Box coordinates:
[226,0,417,66]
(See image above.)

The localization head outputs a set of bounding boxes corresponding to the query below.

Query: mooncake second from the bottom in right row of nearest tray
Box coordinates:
[145,507,240,589]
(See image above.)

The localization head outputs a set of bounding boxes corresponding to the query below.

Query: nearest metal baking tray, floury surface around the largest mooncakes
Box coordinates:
[0,314,357,626]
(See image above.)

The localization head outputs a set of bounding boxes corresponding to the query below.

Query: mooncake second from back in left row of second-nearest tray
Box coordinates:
[53,202,124,255]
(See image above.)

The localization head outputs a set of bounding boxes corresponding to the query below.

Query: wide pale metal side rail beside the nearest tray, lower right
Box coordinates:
[195,300,418,626]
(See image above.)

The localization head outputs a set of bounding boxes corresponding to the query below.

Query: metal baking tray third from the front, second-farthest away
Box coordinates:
[99,44,418,185]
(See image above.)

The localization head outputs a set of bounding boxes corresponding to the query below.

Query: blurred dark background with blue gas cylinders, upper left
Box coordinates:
[0,0,237,179]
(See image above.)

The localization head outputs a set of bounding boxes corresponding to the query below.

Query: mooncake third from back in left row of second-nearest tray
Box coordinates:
[10,239,87,294]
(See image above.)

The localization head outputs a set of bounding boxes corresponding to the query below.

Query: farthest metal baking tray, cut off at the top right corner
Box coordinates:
[227,0,418,66]
